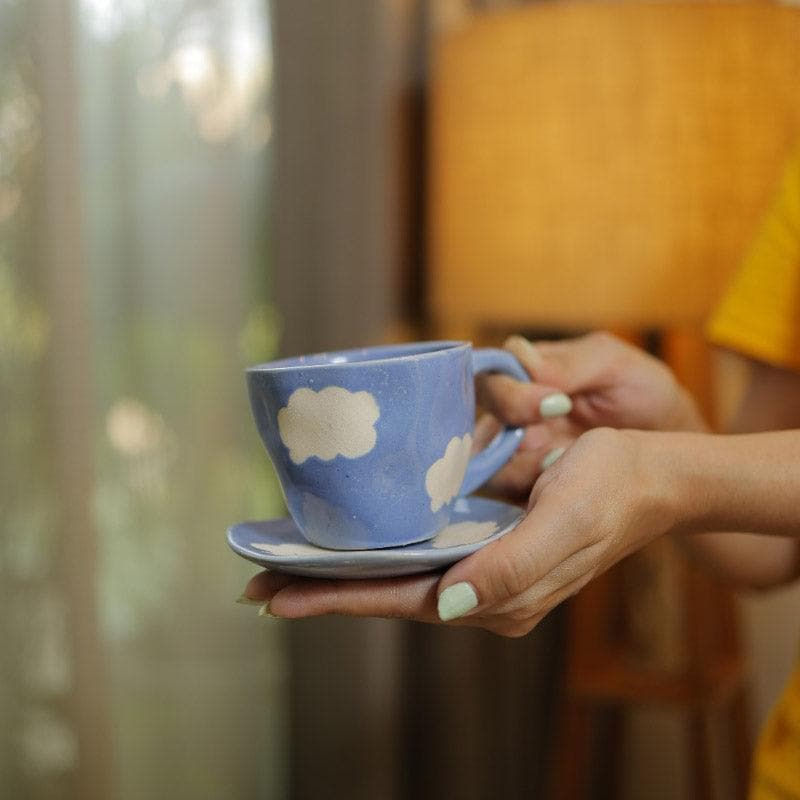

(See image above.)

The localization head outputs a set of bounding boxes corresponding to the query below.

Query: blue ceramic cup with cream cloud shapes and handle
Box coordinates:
[247,342,529,550]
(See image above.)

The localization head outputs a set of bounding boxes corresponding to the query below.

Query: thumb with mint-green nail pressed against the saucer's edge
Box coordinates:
[437,496,571,622]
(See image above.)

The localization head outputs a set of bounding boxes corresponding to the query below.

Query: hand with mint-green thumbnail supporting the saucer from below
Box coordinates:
[245,428,676,637]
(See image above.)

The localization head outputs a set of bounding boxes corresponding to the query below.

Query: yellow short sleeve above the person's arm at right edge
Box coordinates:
[707,151,800,370]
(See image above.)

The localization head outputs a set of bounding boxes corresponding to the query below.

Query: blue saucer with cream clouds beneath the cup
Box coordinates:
[228,497,524,578]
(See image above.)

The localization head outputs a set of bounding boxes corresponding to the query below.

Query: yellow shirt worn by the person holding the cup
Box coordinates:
[708,151,800,800]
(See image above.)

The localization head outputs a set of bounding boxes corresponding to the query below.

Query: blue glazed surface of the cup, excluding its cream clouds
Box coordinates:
[247,342,527,550]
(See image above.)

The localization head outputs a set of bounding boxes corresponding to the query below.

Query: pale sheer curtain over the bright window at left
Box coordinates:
[0,0,287,800]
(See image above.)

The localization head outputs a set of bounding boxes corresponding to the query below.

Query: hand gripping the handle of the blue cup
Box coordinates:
[474,333,705,502]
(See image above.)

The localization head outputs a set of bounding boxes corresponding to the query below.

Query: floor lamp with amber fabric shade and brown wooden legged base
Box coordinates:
[426,0,800,798]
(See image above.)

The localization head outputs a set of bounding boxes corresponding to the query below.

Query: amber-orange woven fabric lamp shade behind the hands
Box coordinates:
[428,2,800,330]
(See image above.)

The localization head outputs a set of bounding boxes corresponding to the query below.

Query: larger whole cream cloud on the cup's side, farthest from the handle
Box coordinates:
[278,386,380,464]
